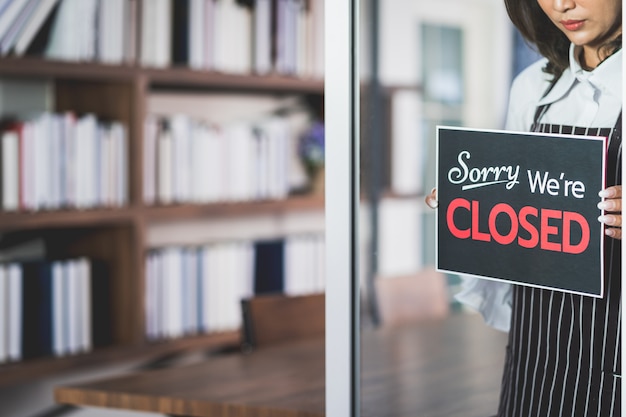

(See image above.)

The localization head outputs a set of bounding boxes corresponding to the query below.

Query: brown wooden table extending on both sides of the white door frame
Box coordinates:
[55,314,506,417]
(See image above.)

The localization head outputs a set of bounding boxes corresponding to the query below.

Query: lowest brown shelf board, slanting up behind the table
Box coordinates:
[0,331,241,387]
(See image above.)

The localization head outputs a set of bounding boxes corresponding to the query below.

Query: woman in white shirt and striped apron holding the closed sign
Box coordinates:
[427,0,622,417]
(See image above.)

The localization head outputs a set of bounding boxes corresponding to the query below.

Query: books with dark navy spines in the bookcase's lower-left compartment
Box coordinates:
[0,258,111,363]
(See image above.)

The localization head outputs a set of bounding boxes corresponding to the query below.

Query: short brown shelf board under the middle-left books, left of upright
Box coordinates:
[0,208,133,231]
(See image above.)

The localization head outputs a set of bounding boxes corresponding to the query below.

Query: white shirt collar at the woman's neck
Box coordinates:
[538,44,622,106]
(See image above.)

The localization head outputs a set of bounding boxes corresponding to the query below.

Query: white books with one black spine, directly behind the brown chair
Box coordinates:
[146,235,325,340]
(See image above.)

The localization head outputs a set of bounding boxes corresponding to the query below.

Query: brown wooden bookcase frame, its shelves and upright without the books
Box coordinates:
[0,4,324,386]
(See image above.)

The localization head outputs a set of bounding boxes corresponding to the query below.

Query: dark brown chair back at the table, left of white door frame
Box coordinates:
[241,293,326,352]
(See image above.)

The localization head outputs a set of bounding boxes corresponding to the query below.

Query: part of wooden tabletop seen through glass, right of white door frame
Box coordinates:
[361,314,507,417]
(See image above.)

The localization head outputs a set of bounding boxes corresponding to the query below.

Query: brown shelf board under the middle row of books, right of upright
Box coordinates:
[144,195,324,221]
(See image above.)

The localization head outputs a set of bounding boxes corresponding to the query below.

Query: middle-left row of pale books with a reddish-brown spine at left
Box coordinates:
[0,112,128,211]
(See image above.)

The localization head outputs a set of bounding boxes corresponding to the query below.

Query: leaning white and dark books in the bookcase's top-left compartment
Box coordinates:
[0,0,136,64]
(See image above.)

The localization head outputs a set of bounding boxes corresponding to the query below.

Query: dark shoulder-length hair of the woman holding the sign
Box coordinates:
[504,0,622,77]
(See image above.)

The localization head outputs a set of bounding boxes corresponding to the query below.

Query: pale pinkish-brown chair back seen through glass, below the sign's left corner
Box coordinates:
[375,267,450,325]
